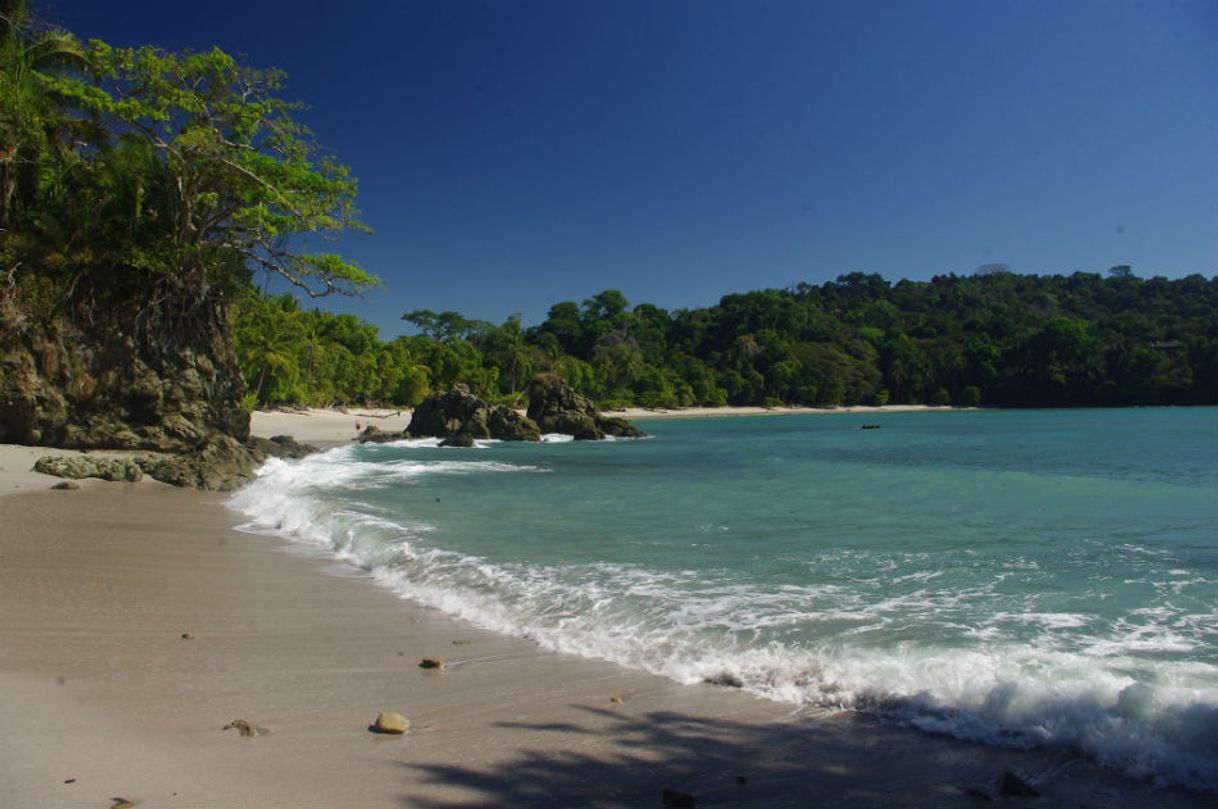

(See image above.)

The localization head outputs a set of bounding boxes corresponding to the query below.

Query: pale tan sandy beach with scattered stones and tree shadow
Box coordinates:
[0,411,1212,808]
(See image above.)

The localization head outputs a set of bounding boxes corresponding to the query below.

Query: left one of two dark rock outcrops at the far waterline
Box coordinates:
[406,384,541,446]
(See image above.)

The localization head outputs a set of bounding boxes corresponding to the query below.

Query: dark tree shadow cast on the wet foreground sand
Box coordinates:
[389,705,1205,809]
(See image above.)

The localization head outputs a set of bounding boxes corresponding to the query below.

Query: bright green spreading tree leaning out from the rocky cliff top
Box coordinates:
[45,40,376,337]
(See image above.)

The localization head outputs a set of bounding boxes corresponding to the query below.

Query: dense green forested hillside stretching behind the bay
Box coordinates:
[238,267,1218,407]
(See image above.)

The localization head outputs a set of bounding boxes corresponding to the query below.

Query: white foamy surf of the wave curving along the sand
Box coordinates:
[231,442,1218,791]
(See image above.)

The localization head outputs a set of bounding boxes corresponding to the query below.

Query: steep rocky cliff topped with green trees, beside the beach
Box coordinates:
[0,0,375,448]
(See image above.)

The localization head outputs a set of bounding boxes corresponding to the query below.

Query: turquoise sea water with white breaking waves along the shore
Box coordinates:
[231,408,1218,791]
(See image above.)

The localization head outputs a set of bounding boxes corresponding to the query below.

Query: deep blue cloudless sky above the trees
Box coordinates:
[32,0,1218,337]
